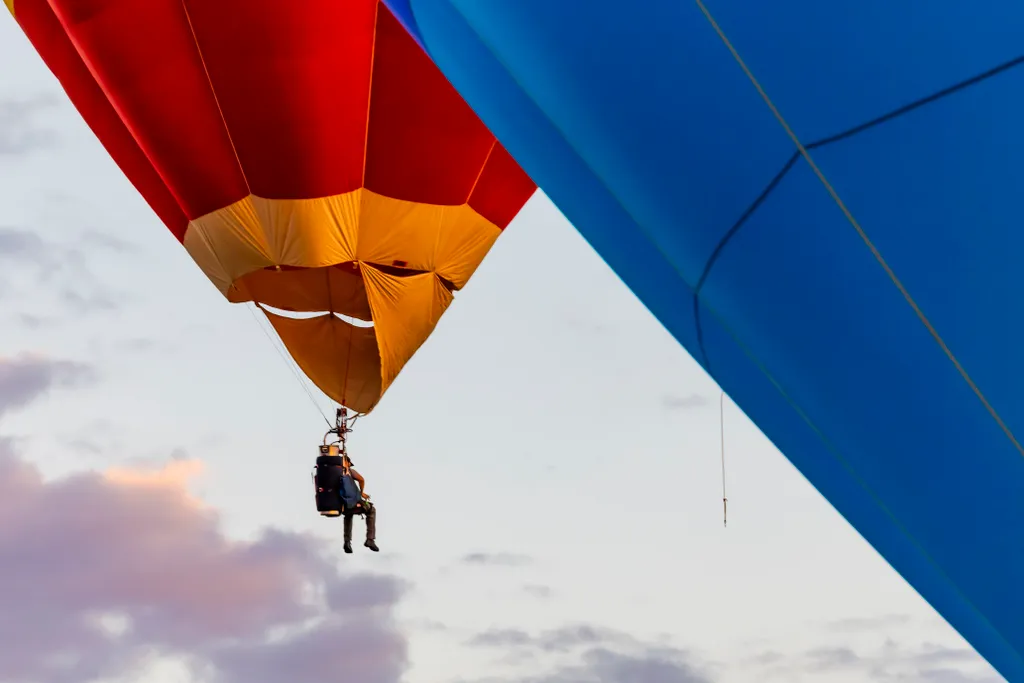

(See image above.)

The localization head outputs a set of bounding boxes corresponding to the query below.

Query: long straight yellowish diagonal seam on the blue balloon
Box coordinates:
[694,0,1024,456]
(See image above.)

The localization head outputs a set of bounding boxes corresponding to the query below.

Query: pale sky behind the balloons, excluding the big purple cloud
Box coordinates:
[0,16,1001,683]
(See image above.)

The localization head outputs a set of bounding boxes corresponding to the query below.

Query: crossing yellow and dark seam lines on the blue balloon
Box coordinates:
[694,0,1024,464]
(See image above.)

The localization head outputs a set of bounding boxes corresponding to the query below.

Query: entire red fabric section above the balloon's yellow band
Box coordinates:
[18,0,534,231]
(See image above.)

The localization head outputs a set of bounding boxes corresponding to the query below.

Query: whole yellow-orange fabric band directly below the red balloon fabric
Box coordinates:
[184,188,501,301]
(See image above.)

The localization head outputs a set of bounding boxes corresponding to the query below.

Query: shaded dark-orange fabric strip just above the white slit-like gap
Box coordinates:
[227,263,373,321]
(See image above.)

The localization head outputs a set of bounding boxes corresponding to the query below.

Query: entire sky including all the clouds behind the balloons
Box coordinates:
[0,13,1002,683]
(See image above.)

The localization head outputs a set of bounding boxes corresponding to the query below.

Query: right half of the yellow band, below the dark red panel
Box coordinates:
[355,189,501,289]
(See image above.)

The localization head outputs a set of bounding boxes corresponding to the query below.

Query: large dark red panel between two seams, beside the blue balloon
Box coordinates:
[366,6,494,205]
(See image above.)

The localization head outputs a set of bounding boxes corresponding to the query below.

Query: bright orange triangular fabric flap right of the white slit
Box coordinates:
[360,263,453,393]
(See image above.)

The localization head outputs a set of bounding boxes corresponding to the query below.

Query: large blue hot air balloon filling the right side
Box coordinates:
[387,0,1024,681]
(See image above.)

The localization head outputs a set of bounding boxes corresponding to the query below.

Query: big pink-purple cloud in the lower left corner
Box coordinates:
[0,441,408,683]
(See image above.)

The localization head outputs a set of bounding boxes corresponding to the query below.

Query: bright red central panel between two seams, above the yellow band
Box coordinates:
[184,0,378,199]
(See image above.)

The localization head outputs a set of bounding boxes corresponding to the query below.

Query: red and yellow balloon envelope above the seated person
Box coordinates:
[4,0,536,413]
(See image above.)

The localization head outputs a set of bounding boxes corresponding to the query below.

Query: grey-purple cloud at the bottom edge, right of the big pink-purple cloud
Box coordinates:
[460,625,712,683]
